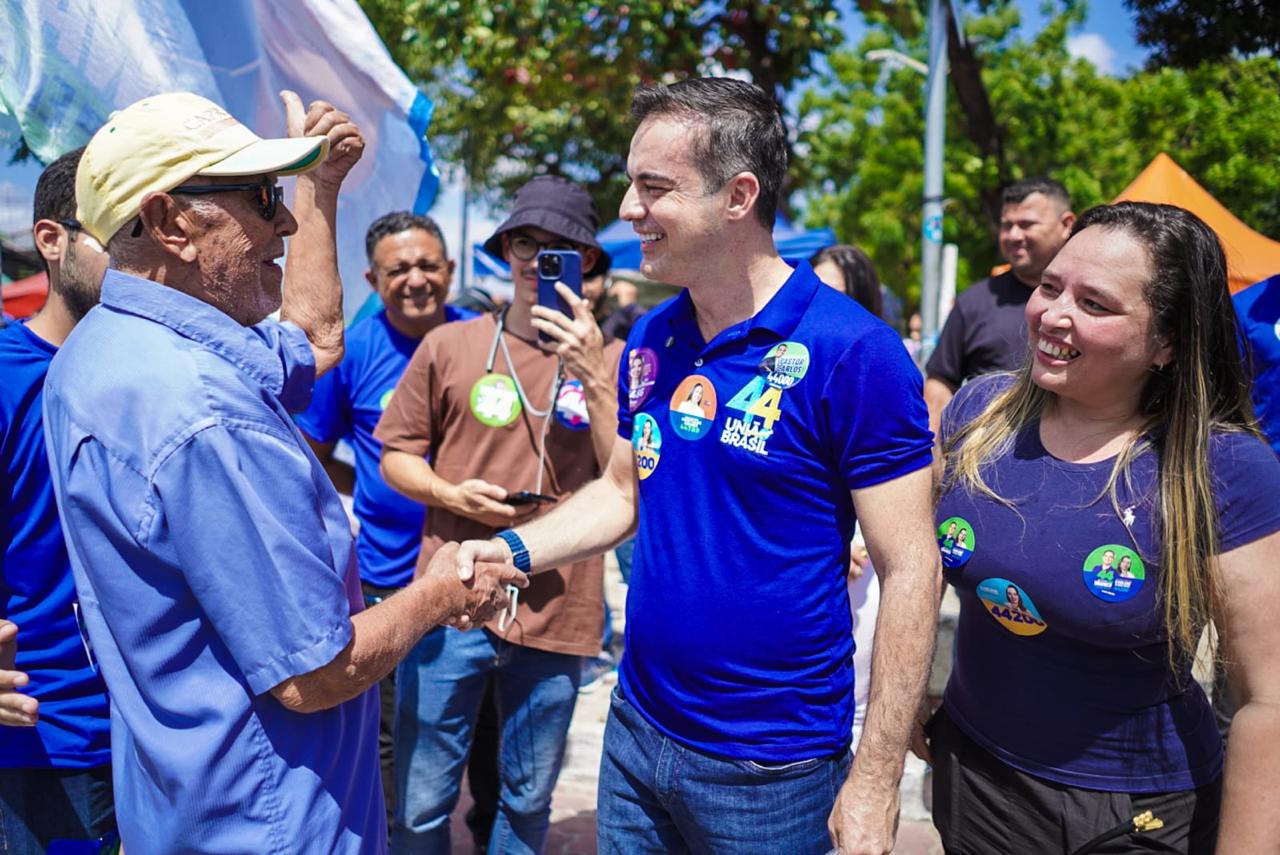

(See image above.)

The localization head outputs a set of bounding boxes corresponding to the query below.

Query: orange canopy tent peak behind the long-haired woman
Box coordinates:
[1115,152,1280,293]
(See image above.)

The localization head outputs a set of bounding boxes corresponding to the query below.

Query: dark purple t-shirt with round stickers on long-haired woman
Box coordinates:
[937,374,1280,792]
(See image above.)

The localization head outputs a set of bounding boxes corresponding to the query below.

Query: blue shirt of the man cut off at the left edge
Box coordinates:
[0,318,111,769]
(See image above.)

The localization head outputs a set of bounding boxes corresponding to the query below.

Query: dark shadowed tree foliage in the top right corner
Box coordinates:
[1125,0,1280,68]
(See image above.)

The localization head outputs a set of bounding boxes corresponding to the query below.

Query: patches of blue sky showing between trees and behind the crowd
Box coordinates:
[0,0,1146,272]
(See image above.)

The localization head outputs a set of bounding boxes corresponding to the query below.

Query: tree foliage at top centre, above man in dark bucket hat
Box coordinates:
[361,0,840,219]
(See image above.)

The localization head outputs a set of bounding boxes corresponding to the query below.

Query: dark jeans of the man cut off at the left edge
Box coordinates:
[0,765,115,855]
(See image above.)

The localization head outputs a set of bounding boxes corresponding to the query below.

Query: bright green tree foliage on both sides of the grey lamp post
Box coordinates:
[796,0,1280,305]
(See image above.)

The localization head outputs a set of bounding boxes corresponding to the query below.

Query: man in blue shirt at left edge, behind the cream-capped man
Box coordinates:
[0,148,115,854]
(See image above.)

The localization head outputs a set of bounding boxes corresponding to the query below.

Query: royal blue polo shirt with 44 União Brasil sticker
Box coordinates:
[618,264,933,763]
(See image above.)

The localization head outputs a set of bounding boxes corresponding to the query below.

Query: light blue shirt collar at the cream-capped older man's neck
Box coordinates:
[101,269,284,396]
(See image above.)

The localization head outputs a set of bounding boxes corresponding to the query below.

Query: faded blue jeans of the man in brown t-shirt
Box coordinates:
[392,627,582,855]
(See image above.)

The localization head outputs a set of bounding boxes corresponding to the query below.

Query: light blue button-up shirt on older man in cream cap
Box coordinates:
[45,270,387,855]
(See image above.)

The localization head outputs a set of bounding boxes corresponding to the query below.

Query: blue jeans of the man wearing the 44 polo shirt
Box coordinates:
[595,687,851,855]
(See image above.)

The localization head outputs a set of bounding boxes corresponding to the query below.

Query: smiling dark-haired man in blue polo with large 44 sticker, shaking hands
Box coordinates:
[458,78,941,852]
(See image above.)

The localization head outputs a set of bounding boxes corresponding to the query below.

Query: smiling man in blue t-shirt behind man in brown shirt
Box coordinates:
[296,211,475,819]
